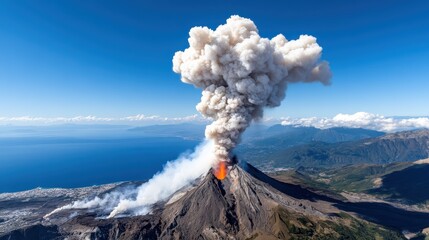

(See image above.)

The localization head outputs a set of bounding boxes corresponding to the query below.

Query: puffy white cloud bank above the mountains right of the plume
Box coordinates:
[282,112,429,132]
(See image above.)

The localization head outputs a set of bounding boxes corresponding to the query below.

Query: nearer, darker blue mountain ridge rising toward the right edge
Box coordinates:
[246,129,429,169]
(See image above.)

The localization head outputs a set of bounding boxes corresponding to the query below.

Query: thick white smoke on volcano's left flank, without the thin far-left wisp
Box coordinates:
[109,141,215,218]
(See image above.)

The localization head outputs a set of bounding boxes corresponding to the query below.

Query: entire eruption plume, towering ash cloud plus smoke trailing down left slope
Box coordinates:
[47,16,331,217]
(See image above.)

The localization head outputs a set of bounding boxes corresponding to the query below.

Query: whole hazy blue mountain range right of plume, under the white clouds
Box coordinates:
[241,129,429,170]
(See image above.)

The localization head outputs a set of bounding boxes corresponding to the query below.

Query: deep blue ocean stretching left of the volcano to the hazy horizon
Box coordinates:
[0,125,200,193]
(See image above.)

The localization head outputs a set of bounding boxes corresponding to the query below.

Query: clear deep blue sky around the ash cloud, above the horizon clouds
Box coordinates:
[0,0,429,117]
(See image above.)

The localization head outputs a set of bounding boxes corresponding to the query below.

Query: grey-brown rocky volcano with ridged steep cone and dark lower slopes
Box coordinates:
[0,163,408,239]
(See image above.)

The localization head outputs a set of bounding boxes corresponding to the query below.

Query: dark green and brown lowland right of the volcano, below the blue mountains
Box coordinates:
[270,162,429,207]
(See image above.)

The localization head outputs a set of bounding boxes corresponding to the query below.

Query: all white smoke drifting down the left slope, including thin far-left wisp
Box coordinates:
[44,141,215,219]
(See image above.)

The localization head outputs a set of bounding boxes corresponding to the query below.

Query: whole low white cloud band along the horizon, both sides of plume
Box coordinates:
[0,112,429,132]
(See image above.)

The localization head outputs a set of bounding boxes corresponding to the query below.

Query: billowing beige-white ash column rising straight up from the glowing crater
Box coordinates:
[173,16,331,163]
